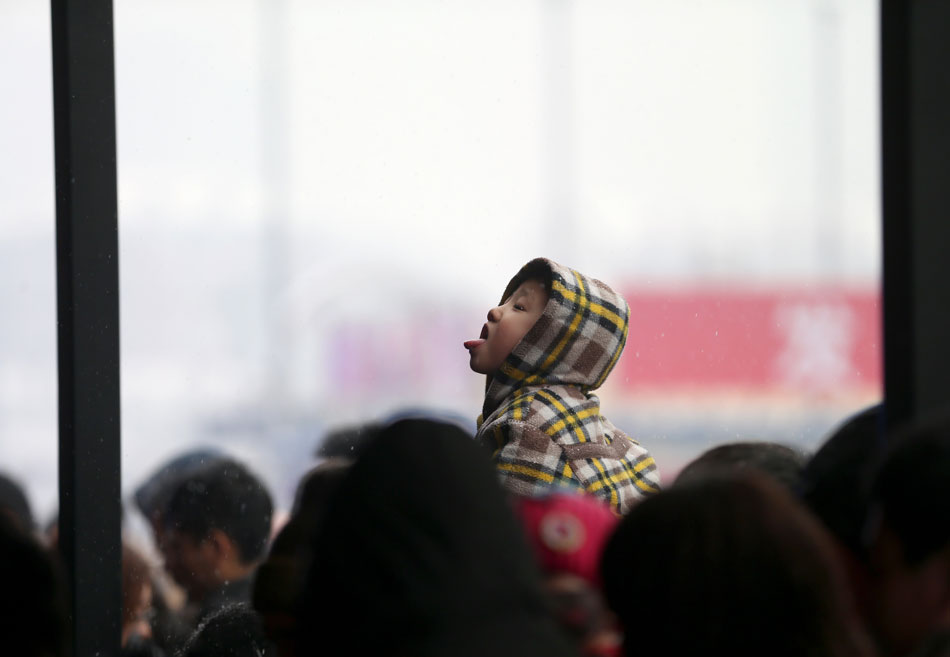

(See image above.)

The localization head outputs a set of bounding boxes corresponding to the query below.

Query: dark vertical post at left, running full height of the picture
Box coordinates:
[51,0,121,657]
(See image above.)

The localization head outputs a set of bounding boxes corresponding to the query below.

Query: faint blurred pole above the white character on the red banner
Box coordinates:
[814,0,847,280]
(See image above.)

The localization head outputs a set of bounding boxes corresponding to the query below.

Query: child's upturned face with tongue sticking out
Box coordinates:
[465,280,548,374]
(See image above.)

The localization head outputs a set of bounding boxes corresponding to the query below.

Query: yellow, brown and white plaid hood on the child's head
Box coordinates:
[482,258,630,418]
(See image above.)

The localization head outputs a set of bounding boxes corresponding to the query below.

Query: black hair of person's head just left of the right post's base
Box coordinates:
[801,404,884,561]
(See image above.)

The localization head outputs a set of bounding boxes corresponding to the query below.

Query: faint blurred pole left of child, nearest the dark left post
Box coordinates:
[259,0,291,408]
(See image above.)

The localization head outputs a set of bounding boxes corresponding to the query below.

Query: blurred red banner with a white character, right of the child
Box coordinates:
[611,287,882,393]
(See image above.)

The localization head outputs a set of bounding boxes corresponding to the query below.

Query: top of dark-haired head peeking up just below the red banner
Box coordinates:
[674,442,806,494]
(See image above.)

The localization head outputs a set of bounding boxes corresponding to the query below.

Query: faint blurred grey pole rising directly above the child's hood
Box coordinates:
[541,0,581,262]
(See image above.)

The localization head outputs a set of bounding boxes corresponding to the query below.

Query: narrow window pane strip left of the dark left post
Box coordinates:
[0,0,58,523]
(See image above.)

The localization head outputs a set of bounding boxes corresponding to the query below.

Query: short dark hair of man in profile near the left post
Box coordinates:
[164,459,274,563]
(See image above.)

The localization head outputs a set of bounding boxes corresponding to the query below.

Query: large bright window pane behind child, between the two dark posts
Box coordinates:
[115,0,881,506]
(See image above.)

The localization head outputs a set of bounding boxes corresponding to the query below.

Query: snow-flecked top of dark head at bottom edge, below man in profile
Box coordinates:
[180,604,277,657]
